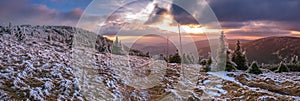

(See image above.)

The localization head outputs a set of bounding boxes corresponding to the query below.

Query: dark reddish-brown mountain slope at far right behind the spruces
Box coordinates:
[242,37,300,64]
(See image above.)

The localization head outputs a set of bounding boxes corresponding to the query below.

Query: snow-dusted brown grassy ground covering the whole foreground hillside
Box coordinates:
[0,26,300,101]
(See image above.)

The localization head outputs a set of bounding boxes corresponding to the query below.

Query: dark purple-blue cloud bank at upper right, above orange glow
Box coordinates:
[210,0,300,22]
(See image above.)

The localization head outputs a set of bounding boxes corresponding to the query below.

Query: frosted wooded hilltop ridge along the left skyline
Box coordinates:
[0,25,112,52]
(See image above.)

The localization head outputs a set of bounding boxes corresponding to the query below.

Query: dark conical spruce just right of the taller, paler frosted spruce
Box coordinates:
[232,40,248,70]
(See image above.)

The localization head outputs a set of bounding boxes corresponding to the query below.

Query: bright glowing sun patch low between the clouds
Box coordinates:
[181,25,206,34]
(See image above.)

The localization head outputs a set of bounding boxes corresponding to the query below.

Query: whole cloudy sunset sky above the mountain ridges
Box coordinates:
[0,0,300,40]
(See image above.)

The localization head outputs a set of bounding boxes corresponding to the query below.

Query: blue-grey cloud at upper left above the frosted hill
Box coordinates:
[0,0,83,26]
